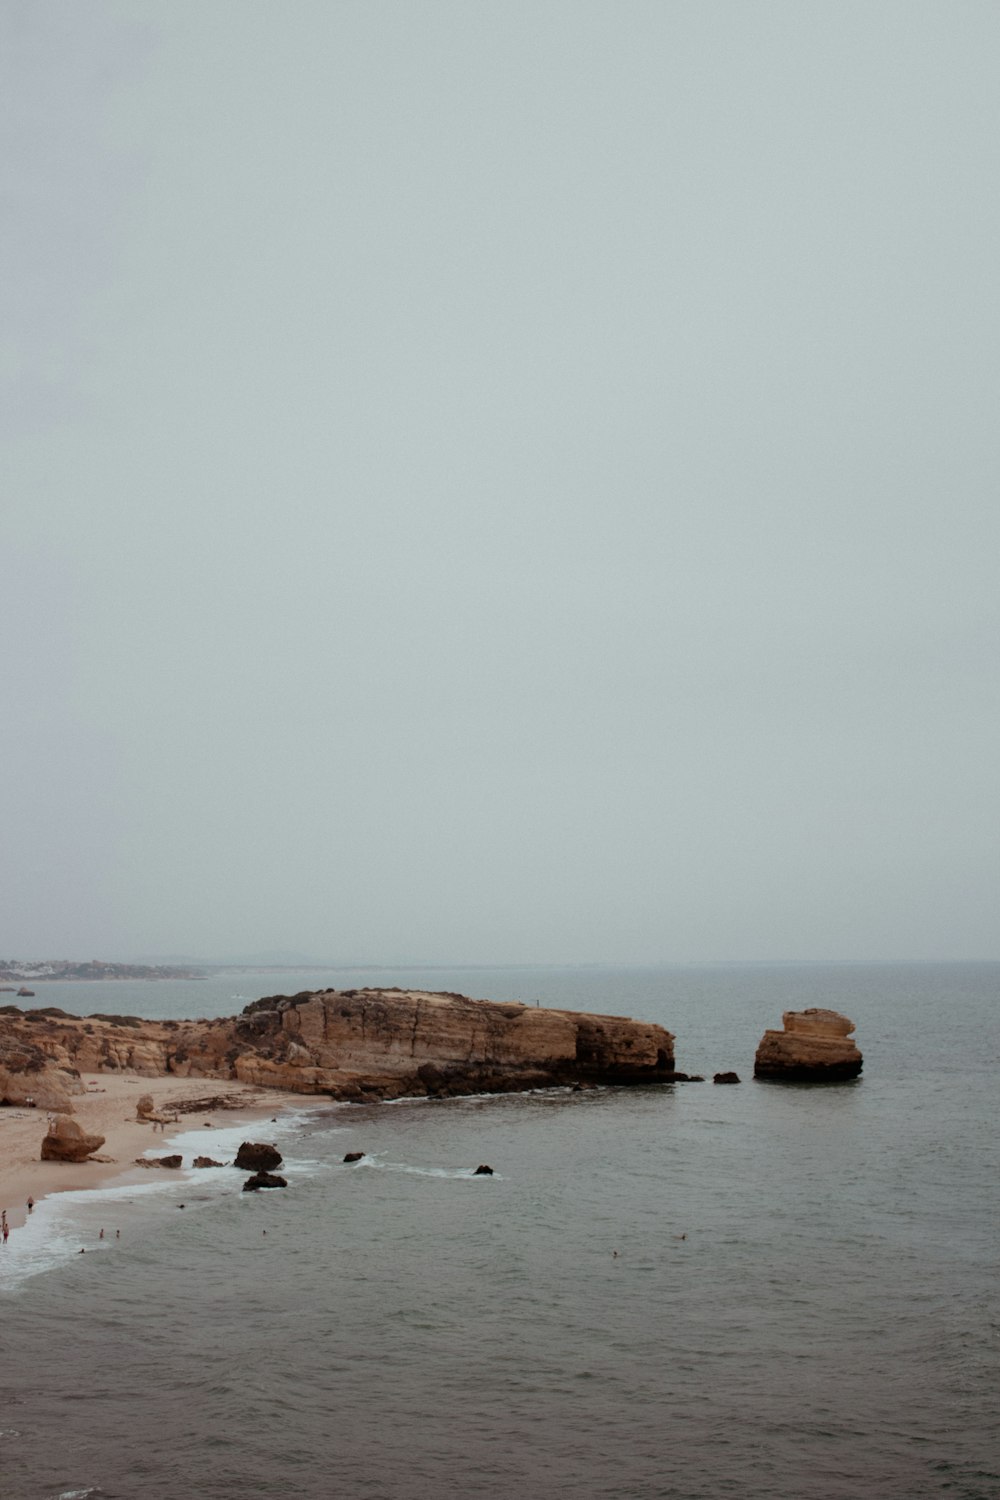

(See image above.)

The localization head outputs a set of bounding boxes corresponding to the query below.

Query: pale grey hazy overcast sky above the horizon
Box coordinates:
[0,0,1000,963]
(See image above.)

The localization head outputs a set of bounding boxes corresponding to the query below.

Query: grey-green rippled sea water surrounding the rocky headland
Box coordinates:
[0,965,1000,1500]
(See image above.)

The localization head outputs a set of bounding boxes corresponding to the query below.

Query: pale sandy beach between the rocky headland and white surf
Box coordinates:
[0,1073,304,1229]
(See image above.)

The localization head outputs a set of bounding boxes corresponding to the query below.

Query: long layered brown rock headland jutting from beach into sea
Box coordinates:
[0,990,675,1103]
